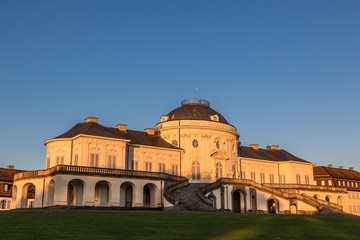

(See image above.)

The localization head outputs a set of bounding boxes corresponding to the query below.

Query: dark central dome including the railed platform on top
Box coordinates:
[166,98,228,124]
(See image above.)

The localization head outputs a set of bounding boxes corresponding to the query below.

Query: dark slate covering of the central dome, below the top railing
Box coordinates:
[167,103,229,124]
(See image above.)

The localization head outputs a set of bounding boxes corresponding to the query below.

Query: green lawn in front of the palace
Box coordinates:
[0,210,360,240]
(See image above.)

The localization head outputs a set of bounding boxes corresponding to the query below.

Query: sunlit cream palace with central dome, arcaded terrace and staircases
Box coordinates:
[11,99,354,214]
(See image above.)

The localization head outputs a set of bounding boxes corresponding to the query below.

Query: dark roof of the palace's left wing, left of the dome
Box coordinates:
[53,122,179,149]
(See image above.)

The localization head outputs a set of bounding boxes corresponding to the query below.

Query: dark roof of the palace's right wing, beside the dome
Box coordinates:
[238,146,309,163]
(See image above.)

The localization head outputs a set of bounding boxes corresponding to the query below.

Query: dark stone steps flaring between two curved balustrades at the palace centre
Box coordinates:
[169,183,218,211]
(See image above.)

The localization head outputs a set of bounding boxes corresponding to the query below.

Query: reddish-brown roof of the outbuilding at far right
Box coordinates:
[314,166,360,180]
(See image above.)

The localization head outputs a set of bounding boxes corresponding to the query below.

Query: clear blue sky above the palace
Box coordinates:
[0,0,360,170]
